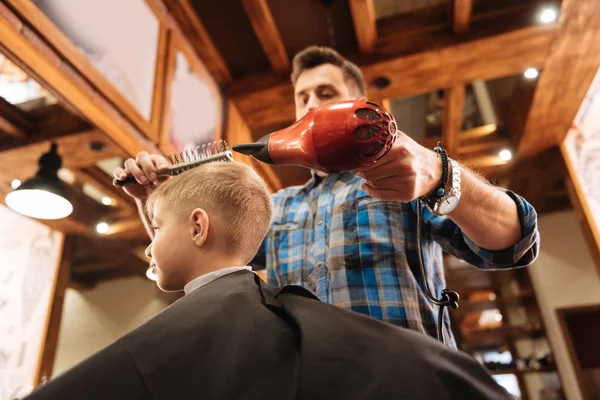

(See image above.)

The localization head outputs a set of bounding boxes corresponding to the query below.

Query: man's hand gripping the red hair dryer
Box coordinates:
[353,132,442,203]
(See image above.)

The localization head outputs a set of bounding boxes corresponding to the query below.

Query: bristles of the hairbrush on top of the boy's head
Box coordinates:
[167,140,233,175]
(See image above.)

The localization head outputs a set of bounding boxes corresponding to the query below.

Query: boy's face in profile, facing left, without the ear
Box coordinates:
[146,199,198,292]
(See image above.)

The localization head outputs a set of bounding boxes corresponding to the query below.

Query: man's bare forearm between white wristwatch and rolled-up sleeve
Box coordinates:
[448,167,522,250]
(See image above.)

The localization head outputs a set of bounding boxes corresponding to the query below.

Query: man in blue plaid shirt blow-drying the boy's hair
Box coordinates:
[114,46,539,346]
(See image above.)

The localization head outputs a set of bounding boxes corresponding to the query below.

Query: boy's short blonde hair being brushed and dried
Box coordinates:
[146,161,272,261]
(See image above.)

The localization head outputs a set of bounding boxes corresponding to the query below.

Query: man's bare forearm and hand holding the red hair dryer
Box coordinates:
[355,133,523,250]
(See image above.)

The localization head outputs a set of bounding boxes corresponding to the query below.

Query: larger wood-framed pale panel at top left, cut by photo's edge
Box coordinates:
[27,0,166,140]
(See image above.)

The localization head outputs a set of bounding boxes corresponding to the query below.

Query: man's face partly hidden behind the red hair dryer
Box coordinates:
[294,64,356,120]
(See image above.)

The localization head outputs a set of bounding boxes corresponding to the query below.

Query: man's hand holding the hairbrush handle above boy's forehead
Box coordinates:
[113,151,169,200]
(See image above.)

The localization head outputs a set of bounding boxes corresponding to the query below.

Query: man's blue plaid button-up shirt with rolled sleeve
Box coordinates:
[262,173,539,343]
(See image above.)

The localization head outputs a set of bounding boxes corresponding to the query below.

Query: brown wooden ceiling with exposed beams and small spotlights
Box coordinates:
[0,0,600,283]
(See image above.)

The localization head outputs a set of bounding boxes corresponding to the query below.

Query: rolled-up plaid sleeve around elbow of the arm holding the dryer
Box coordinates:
[412,190,540,270]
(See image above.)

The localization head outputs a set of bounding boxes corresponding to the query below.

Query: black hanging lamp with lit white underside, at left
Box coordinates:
[6,143,73,219]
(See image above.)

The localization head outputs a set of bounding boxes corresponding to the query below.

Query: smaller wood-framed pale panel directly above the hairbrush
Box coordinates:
[160,35,224,152]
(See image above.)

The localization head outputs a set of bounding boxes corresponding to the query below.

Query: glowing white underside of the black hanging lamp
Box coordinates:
[6,189,73,219]
